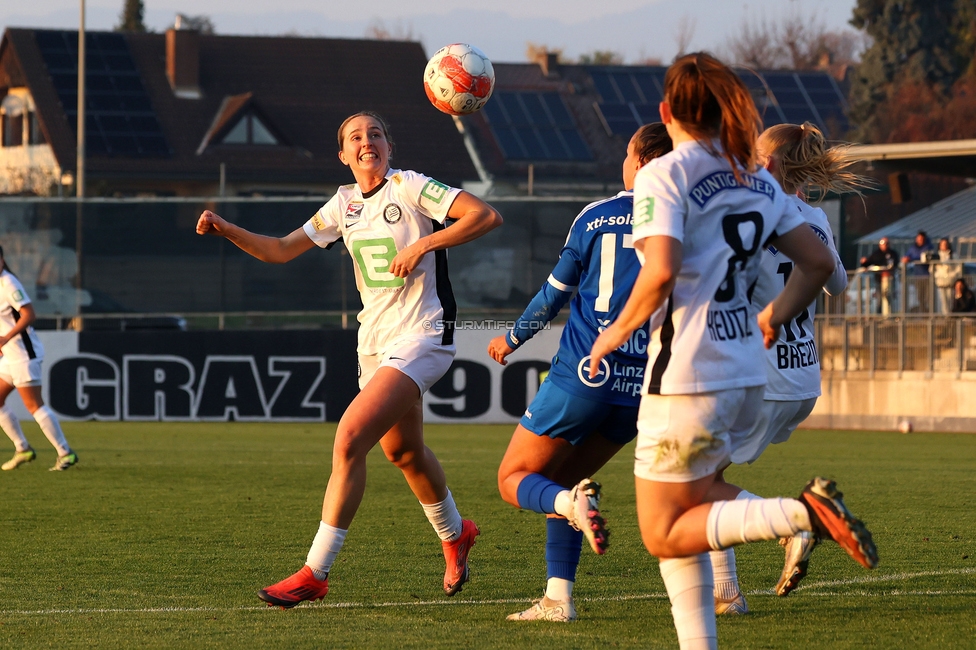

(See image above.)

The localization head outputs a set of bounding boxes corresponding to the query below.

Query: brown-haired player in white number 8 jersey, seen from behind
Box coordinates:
[590,53,878,648]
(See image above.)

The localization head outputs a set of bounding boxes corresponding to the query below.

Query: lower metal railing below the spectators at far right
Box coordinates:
[816,314,976,373]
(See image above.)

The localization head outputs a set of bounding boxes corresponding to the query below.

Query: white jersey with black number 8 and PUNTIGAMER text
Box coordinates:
[633,141,803,395]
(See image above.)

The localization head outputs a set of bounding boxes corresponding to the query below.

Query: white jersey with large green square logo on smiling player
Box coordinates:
[304,169,461,355]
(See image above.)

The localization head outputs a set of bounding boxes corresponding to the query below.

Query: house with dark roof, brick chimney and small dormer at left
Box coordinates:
[0,29,479,196]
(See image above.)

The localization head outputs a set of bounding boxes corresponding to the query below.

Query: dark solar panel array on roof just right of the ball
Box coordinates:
[485,91,593,160]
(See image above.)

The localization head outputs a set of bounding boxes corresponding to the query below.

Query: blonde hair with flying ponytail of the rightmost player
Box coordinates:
[759,122,875,195]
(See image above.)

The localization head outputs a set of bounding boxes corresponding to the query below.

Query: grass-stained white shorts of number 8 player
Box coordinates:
[634,386,765,483]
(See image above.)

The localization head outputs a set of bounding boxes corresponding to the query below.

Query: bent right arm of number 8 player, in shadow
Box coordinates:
[759,227,835,349]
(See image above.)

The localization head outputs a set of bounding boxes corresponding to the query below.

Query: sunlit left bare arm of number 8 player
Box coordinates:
[590,233,684,379]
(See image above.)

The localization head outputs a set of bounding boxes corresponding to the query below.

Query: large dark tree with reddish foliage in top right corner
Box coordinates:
[850,0,976,142]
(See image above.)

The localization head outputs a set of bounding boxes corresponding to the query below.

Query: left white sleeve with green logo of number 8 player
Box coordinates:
[633,160,688,242]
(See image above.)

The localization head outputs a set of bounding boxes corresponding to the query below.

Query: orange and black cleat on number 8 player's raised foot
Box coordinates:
[800,476,878,569]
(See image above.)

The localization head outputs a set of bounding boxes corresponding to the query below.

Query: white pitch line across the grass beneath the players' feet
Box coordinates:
[0,568,976,616]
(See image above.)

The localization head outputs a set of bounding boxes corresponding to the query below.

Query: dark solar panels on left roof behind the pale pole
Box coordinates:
[34,30,170,156]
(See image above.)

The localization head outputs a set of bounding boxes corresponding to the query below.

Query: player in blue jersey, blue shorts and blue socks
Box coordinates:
[488,123,671,622]
